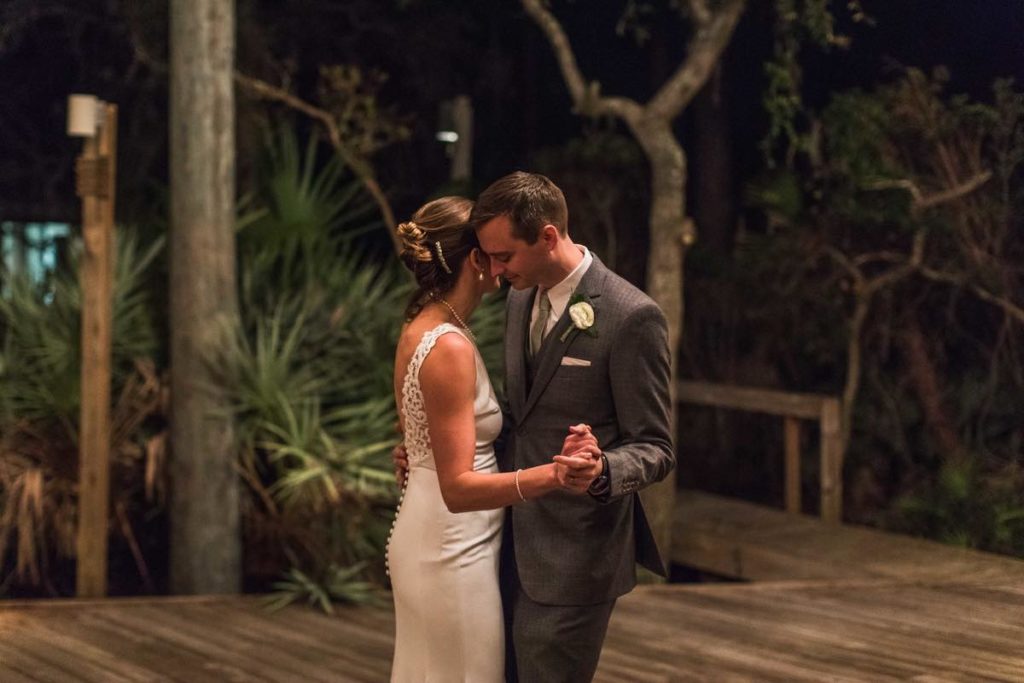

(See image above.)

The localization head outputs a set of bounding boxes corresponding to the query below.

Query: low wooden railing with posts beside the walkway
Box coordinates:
[676,381,843,523]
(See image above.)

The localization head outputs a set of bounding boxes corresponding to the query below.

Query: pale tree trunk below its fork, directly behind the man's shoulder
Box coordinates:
[631,120,694,561]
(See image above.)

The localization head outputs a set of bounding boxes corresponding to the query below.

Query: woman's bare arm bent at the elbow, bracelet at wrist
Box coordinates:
[420,334,562,512]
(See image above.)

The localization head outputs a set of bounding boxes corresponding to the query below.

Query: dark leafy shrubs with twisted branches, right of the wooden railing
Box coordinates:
[737,70,1024,554]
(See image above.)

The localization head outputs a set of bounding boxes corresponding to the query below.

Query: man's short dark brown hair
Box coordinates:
[469,171,569,245]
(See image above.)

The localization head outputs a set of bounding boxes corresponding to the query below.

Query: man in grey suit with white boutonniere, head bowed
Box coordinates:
[470,172,675,683]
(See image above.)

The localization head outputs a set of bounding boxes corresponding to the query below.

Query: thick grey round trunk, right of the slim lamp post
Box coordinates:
[170,0,242,593]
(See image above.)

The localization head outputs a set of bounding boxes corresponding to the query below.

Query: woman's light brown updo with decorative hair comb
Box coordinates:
[397,197,479,321]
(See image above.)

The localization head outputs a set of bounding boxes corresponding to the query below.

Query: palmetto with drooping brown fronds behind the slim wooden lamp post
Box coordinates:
[0,231,164,594]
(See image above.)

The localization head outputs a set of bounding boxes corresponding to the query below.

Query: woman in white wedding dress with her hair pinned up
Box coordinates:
[387,197,596,683]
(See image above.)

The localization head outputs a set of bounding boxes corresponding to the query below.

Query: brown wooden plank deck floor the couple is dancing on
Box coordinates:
[6,580,1024,683]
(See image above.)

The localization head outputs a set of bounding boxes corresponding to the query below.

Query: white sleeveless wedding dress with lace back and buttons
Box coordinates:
[387,323,505,683]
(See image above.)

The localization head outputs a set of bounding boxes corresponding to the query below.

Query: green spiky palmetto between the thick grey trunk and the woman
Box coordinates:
[229,129,503,607]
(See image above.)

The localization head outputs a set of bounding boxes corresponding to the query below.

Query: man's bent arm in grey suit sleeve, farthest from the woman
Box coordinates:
[598,303,676,500]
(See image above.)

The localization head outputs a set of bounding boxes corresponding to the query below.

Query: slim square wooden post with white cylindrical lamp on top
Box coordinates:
[68,94,118,597]
